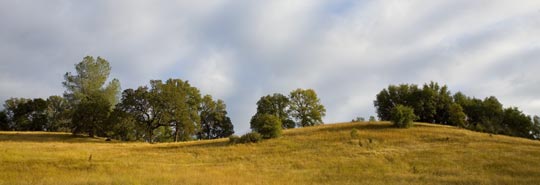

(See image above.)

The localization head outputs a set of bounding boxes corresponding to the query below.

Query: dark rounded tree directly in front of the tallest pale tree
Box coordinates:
[71,94,111,137]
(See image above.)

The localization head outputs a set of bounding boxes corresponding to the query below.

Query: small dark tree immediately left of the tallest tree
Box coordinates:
[45,96,71,131]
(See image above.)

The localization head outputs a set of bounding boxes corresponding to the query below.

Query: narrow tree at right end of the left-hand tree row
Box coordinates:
[197,95,234,139]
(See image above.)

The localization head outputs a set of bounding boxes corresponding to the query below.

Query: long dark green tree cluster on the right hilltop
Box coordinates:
[374,82,540,138]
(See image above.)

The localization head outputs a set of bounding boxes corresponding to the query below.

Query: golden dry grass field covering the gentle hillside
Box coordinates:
[0,122,540,185]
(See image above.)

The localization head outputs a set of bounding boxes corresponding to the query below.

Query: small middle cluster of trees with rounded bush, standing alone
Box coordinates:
[250,89,326,139]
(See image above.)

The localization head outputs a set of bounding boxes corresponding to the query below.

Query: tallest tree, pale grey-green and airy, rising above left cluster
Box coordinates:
[62,56,120,135]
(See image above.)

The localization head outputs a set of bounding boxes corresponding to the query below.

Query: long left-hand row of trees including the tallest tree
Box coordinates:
[0,56,234,142]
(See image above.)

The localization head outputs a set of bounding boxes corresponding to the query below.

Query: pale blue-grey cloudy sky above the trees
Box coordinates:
[0,0,540,133]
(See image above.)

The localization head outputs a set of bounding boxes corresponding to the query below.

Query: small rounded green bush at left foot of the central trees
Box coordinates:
[251,114,282,139]
